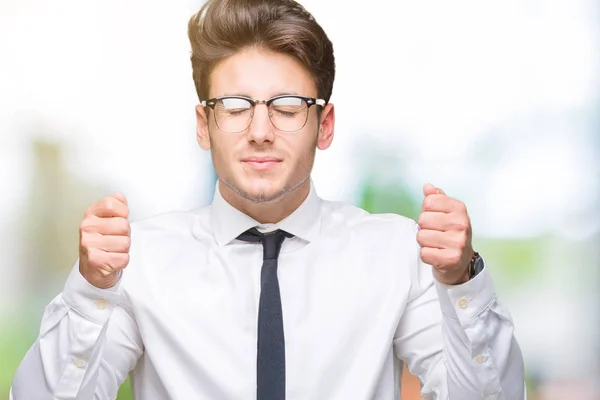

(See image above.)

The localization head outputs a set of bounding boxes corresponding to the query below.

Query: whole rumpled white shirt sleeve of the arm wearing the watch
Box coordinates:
[393,225,525,400]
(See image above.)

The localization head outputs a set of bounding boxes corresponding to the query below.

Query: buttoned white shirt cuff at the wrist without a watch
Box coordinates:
[63,261,121,325]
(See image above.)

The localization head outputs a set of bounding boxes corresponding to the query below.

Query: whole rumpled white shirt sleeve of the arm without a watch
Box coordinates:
[11,263,143,400]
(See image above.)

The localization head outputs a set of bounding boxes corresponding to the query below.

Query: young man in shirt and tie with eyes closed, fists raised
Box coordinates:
[12,0,524,400]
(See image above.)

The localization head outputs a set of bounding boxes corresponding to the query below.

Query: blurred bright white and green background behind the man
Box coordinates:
[0,0,600,400]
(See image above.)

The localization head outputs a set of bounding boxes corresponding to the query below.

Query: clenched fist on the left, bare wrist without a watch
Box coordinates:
[79,193,131,289]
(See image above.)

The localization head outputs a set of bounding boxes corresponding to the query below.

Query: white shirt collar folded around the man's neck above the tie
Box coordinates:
[204,179,321,246]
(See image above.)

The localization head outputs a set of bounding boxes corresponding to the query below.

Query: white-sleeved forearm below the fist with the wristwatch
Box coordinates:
[436,269,525,400]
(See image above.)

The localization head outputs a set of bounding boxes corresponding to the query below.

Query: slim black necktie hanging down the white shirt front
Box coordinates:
[238,228,293,400]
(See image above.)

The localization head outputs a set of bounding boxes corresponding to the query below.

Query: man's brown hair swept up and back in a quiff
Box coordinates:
[188,0,335,102]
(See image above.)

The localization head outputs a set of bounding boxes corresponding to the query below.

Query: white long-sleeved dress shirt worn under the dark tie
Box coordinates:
[12,182,525,400]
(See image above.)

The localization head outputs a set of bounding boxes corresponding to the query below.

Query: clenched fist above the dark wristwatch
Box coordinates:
[417,184,474,285]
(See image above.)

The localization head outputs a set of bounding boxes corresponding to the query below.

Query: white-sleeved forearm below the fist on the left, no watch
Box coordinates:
[12,268,125,400]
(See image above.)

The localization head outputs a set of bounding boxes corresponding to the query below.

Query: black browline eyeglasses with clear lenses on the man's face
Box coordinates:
[200,95,325,133]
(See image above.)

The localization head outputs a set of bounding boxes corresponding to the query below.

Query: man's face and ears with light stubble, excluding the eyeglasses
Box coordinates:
[197,48,333,202]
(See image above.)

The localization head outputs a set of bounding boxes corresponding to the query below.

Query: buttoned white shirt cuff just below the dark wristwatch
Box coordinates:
[434,261,496,326]
